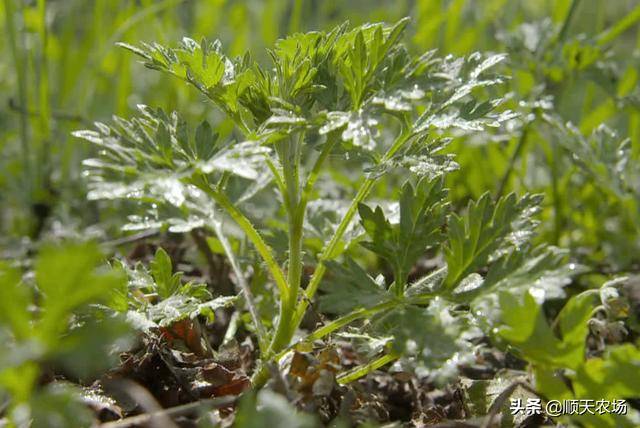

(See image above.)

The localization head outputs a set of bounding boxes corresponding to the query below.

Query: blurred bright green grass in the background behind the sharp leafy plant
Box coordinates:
[0,0,640,269]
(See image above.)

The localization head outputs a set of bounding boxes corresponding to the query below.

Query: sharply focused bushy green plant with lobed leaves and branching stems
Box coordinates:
[75,20,596,385]
